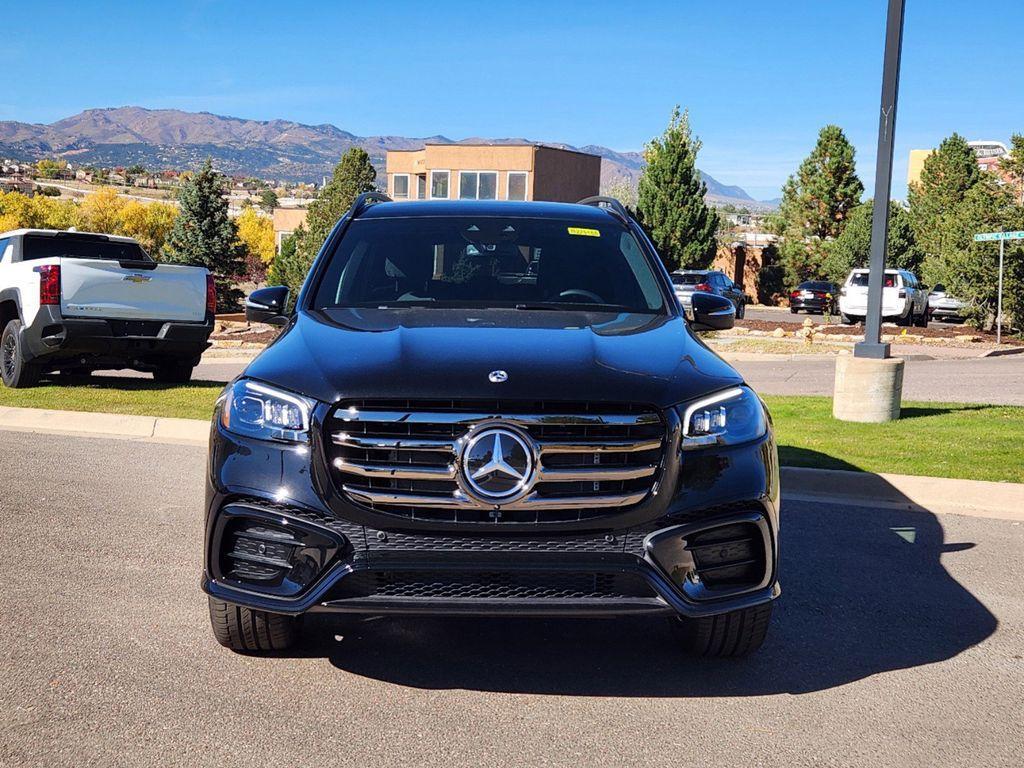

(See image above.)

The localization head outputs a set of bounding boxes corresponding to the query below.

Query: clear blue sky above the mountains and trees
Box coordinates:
[0,0,1024,199]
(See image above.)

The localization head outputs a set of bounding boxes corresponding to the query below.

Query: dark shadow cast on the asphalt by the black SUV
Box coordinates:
[305,454,997,696]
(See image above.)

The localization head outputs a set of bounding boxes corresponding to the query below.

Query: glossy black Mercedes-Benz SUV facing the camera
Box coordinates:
[203,193,779,655]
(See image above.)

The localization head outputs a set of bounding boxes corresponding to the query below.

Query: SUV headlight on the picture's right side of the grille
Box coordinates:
[679,387,768,451]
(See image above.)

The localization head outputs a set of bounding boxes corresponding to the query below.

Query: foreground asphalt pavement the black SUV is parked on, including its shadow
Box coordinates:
[0,432,1024,768]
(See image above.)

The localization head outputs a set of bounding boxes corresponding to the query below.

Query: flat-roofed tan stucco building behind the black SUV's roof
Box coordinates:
[387,144,601,203]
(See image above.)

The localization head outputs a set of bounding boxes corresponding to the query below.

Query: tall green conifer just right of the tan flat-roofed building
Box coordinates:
[637,105,718,270]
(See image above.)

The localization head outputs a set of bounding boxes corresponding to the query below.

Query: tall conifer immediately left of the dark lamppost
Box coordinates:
[774,125,864,285]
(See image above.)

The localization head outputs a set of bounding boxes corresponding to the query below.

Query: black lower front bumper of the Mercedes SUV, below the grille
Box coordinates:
[202,502,779,616]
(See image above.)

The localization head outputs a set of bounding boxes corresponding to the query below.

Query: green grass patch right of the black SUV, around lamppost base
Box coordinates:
[765,396,1024,482]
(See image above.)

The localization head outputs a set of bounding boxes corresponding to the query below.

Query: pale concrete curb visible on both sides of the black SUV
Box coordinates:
[0,407,1024,521]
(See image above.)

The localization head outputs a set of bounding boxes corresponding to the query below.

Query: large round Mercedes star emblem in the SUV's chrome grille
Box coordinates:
[462,427,534,502]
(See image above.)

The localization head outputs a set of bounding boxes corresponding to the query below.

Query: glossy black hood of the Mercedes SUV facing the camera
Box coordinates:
[246,308,741,408]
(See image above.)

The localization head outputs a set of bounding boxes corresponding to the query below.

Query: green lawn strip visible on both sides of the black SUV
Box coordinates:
[0,376,1024,482]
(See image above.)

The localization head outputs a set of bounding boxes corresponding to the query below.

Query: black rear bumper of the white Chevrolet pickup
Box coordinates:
[22,306,213,367]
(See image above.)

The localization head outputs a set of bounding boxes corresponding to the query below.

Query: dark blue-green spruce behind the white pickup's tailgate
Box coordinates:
[165,160,245,311]
